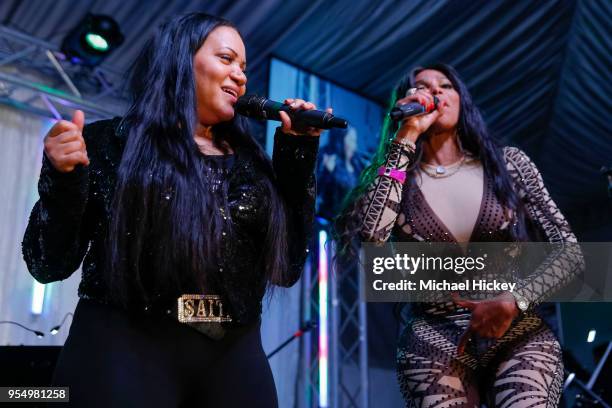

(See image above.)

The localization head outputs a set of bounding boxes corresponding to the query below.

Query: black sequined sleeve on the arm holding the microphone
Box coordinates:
[272,129,319,287]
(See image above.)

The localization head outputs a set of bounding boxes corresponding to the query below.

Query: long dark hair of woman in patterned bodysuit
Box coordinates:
[335,63,528,254]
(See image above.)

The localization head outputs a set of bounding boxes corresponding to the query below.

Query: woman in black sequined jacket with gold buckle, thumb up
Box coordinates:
[23,13,321,408]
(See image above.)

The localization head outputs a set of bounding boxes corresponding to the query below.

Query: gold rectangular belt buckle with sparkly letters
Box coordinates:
[177,294,232,323]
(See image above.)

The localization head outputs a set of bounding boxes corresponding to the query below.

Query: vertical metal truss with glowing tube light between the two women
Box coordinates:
[299,226,369,408]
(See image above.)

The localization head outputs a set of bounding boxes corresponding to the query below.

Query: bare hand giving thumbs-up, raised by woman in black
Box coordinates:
[44,110,89,173]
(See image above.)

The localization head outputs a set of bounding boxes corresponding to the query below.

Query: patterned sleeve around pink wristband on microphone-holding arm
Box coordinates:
[360,143,414,243]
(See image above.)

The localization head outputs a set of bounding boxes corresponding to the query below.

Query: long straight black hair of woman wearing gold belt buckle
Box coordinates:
[107,13,288,305]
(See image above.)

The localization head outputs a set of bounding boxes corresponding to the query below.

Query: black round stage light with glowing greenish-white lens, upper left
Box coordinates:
[62,13,124,67]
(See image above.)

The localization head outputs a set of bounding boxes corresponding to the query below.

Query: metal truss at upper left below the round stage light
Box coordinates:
[0,25,128,119]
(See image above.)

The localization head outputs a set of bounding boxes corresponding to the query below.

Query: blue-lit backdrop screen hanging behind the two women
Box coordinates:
[266,58,384,220]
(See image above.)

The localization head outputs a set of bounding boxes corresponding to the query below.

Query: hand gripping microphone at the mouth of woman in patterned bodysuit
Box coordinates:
[389,88,440,143]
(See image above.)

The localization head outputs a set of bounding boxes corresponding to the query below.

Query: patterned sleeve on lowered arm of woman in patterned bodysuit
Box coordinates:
[504,147,585,307]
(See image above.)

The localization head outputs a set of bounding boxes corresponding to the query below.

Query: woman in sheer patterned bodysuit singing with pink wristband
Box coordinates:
[337,64,584,407]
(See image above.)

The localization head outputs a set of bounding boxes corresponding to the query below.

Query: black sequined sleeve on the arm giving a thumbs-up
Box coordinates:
[22,139,89,283]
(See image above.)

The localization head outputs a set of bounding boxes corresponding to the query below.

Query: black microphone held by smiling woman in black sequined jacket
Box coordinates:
[234,95,348,129]
